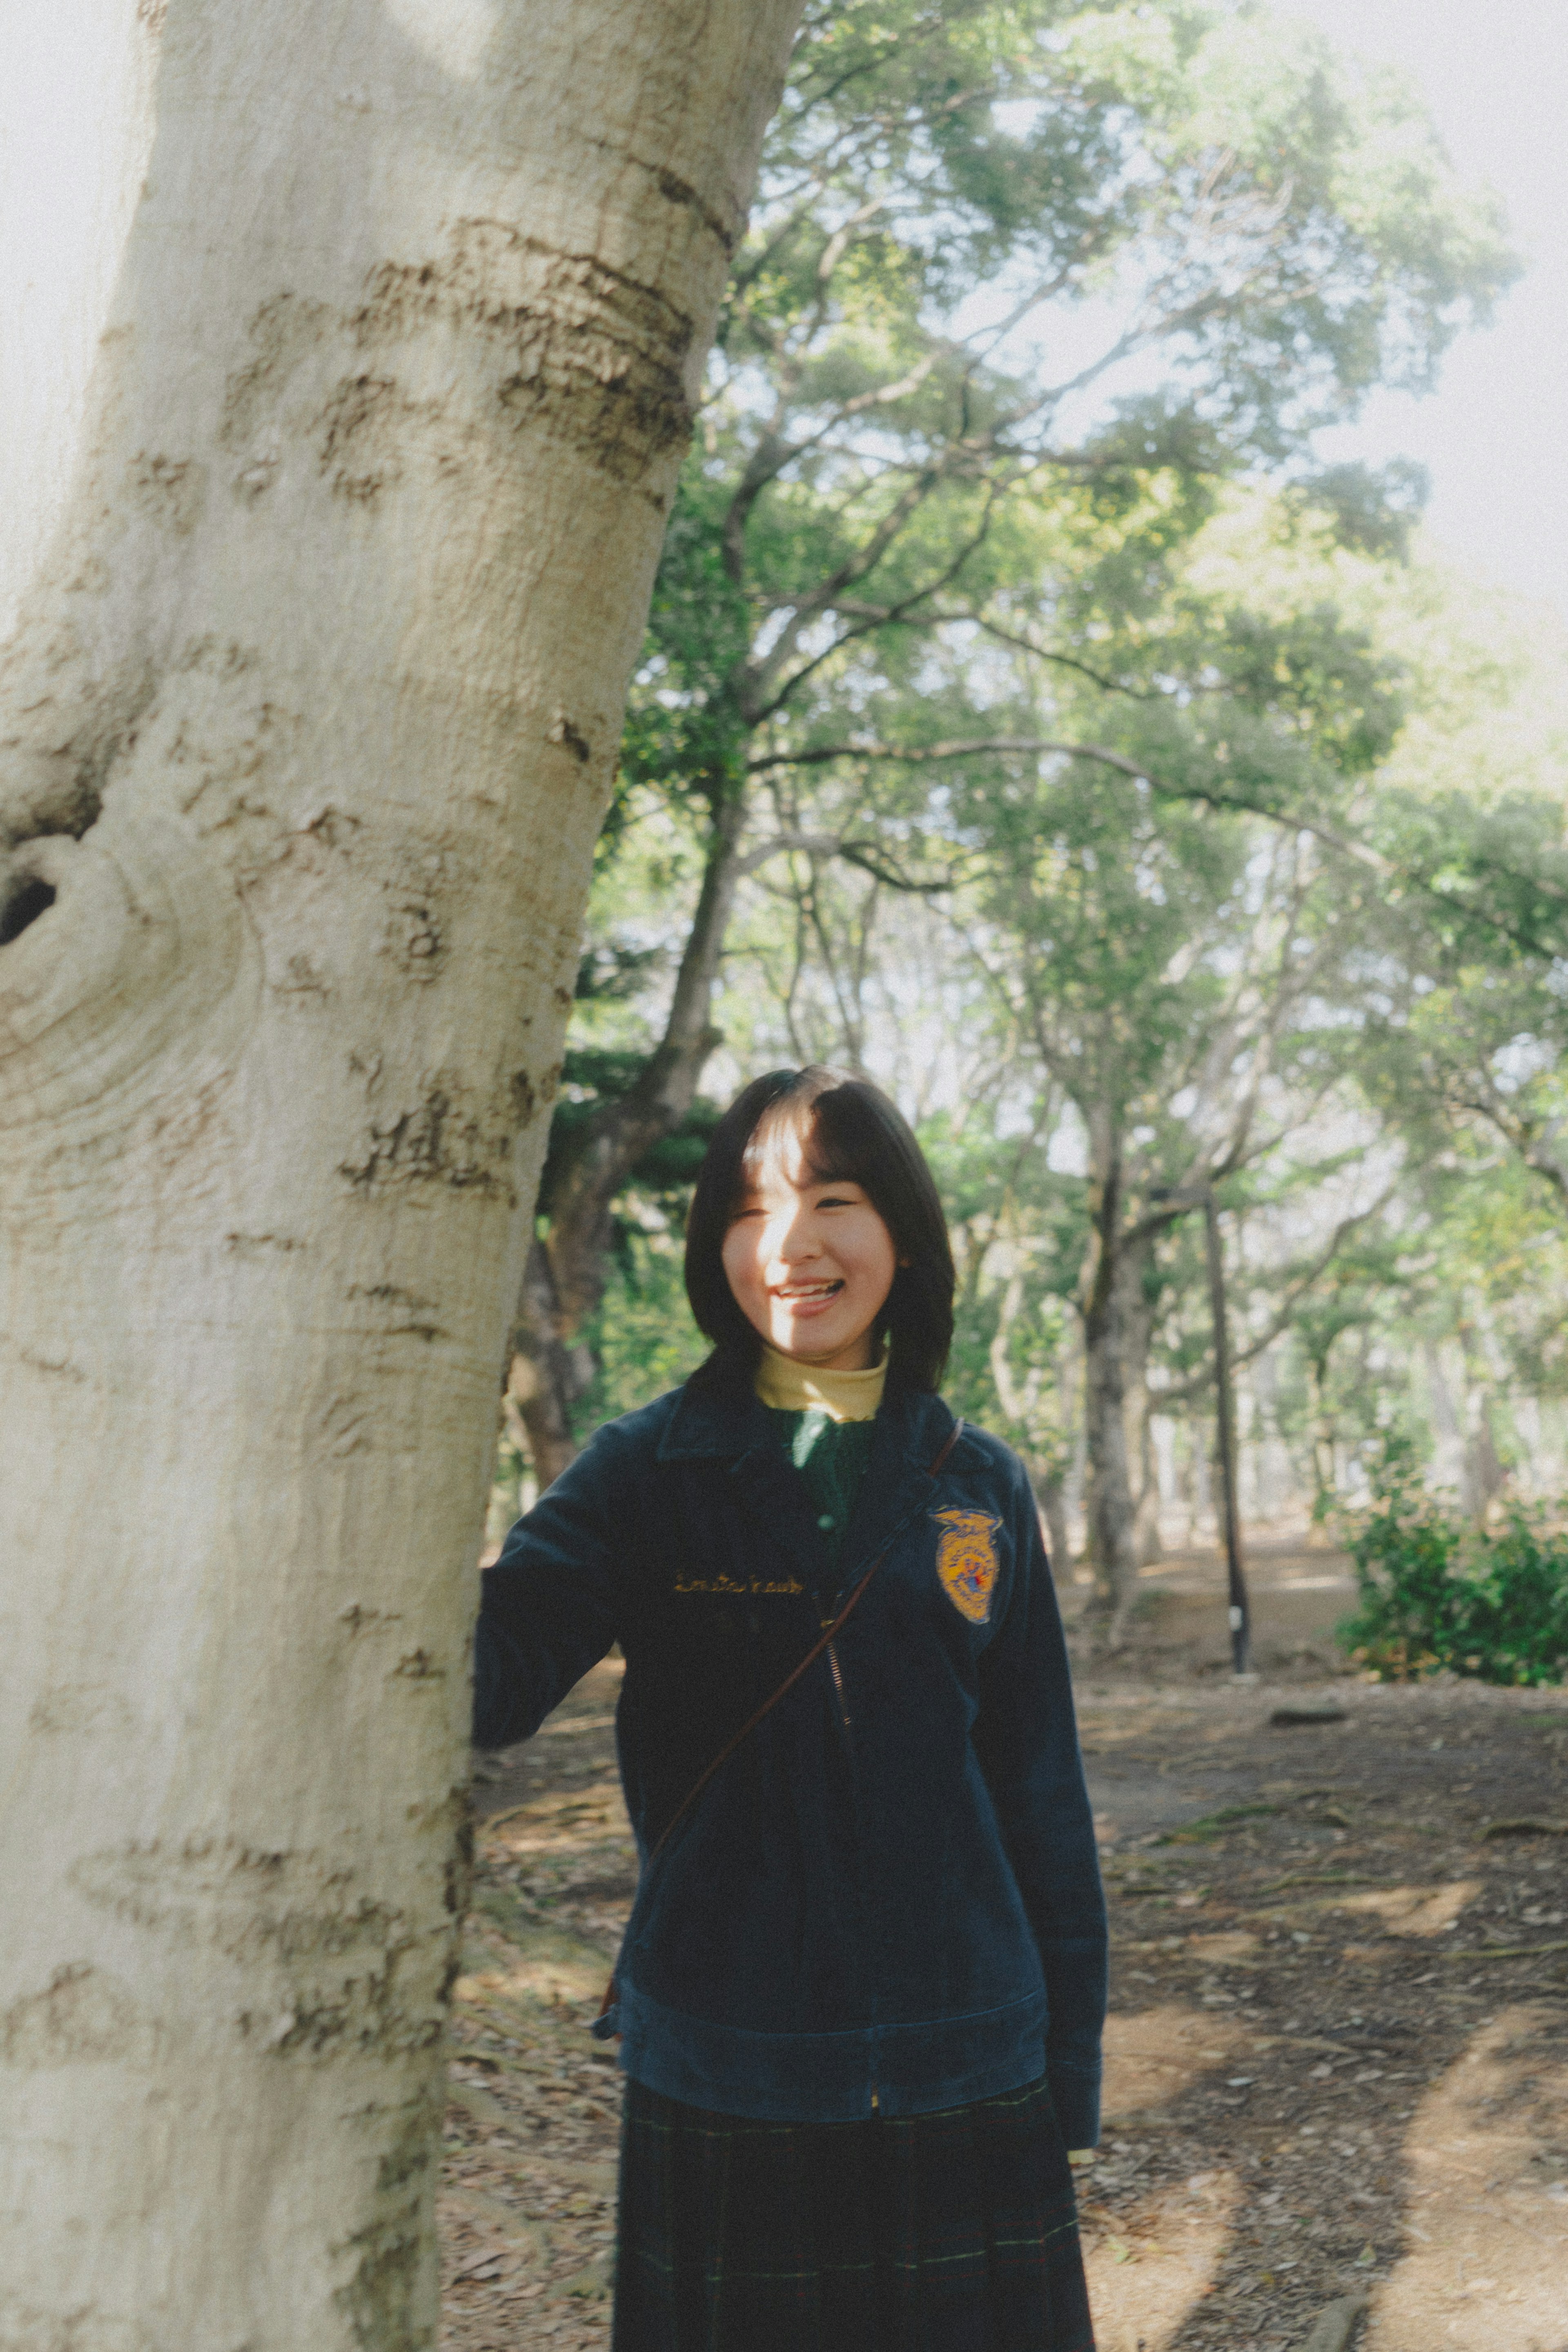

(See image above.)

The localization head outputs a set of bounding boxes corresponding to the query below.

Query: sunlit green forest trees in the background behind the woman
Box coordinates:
[491,0,1568,1656]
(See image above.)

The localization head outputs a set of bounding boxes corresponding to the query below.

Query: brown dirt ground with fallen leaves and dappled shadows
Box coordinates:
[442,1536,1568,2352]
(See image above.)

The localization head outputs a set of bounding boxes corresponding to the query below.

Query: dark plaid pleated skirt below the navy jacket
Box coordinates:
[614,2082,1093,2352]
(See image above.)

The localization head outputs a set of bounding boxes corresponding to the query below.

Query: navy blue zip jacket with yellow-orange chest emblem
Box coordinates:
[475,1376,1105,2147]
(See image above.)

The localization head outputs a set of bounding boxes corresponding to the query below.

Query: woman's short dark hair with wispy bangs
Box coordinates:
[686,1063,954,1388]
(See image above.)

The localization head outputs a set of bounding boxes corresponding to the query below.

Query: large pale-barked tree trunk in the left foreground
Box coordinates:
[0,0,797,2352]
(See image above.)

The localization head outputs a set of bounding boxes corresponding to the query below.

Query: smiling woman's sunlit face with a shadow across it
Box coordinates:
[724,1148,898,1371]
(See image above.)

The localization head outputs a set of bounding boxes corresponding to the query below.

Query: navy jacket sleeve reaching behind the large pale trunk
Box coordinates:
[472,1423,639,1748]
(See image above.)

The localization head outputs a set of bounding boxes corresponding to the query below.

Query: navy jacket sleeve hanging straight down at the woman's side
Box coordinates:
[973,1463,1107,2147]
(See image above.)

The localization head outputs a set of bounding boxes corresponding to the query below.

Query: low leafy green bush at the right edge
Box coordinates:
[1338,1437,1568,1686]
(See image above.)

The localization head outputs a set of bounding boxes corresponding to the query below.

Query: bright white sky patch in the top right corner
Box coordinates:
[1279,0,1568,621]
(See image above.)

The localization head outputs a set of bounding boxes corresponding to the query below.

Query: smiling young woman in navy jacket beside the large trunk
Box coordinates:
[475,1068,1105,2352]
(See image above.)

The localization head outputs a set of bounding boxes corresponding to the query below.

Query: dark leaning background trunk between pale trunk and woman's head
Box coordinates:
[510,786,745,1489]
